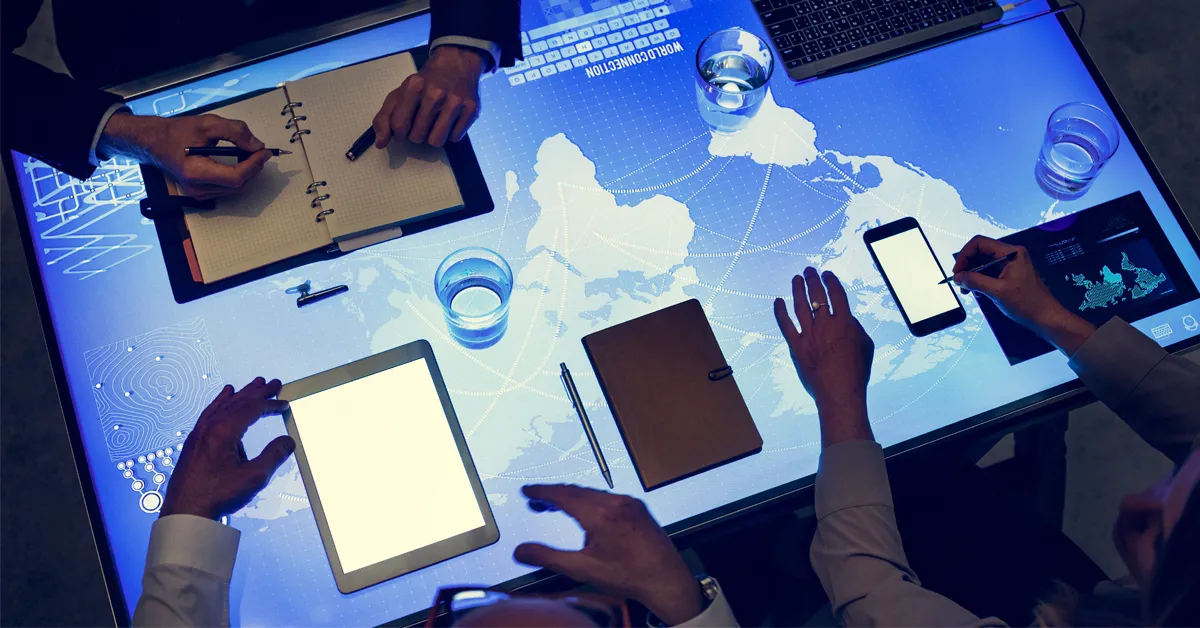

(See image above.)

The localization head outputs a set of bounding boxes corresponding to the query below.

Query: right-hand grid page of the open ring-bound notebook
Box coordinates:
[288,53,463,240]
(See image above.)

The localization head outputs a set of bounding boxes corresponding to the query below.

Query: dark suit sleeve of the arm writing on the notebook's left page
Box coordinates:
[0,0,121,179]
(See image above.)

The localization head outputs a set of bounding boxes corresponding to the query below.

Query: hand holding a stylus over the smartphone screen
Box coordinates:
[954,235,1096,355]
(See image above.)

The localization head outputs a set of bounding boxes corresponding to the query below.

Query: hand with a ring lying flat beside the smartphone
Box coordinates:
[775,267,875,447]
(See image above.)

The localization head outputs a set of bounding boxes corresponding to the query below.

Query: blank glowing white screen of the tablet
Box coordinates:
[290,359,484,573]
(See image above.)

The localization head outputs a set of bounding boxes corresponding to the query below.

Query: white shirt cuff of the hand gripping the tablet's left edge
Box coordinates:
[146,515,241,581]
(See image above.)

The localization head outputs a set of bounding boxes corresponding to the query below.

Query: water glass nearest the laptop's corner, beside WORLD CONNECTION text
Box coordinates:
[696,29,775,133]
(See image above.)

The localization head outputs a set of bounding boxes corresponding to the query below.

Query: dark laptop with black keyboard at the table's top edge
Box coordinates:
[754,0,1004,80]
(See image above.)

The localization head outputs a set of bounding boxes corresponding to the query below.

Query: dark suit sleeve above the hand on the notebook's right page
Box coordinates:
[430,0,521,66]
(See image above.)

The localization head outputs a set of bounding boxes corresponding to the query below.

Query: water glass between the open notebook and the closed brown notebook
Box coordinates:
[433,246,512,349]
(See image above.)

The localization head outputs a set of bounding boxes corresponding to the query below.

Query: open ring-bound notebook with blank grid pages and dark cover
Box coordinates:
[142,49,493,303]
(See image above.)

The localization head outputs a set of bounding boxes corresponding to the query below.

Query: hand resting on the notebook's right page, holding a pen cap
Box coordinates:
[372,46,485,148]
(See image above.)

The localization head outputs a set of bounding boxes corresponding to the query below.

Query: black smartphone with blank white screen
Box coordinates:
[863,217,967,336]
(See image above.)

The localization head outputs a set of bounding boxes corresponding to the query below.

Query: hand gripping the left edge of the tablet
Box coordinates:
[161,377,296,520]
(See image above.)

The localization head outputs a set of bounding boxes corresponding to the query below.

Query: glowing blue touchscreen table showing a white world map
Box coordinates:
[6,0,1200,626]
